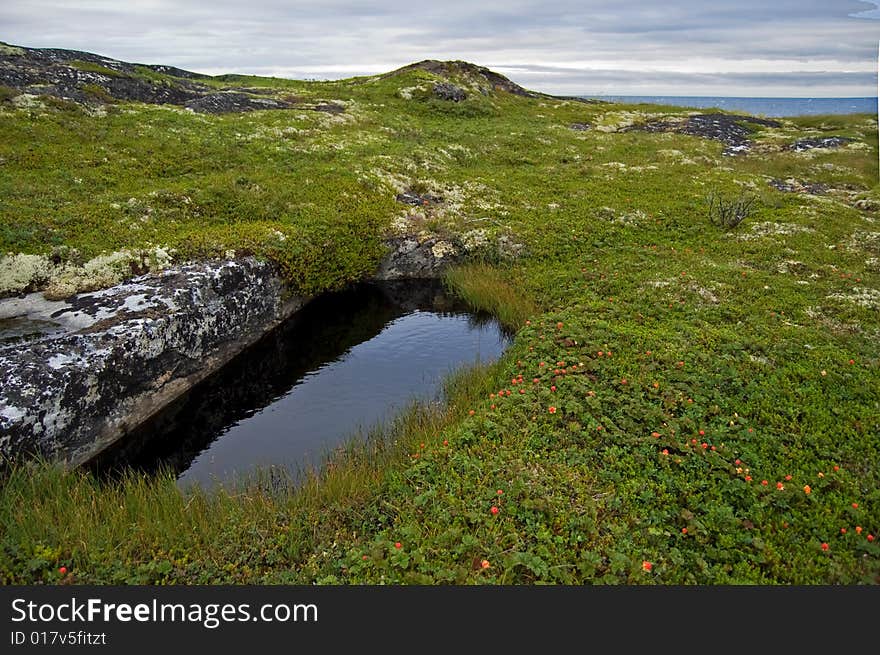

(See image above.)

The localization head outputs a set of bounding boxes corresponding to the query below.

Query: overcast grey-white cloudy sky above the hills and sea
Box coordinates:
[0,0,880,97]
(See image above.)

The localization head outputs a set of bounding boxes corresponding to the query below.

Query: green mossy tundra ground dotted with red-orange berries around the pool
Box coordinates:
[0,62,880,584]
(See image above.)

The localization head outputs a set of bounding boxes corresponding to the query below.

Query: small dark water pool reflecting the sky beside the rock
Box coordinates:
[91,282,509,486]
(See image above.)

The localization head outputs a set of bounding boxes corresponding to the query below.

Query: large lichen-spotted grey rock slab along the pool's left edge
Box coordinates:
[0,259,305,465]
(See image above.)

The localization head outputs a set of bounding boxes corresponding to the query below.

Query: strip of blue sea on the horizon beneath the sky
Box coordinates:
[577,95,877,117]
